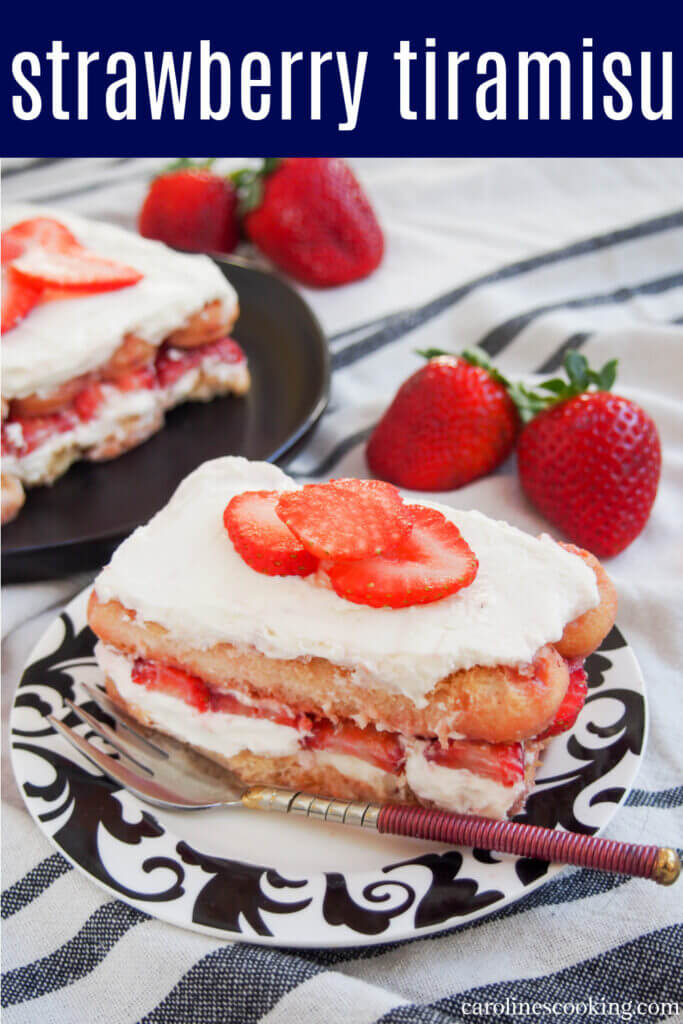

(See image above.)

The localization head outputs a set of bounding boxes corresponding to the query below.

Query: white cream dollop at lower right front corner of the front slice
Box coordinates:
[405,743,524,818]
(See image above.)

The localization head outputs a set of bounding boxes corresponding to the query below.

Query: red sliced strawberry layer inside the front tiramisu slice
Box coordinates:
[125,658,586,788]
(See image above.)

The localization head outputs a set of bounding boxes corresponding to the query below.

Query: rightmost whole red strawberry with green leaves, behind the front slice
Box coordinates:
[517,352,661,558]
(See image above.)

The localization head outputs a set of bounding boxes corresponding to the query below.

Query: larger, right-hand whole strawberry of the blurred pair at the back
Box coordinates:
[233,157,384,288]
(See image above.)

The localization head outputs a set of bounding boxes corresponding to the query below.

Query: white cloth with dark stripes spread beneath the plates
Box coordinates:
[2,160,683,1024]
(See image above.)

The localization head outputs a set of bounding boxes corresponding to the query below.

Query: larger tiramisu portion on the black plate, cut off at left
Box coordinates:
[2,207,249,522]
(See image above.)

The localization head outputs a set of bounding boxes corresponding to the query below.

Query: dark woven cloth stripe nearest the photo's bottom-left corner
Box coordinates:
[2,900,150,1007]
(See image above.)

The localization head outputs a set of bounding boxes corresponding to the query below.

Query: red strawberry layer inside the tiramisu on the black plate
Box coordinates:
[2,338,246,458]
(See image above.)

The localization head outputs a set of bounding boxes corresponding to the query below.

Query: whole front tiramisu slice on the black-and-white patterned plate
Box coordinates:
[88,458,616,817]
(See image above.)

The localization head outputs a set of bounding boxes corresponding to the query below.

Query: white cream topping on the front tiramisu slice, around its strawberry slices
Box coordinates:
[95,457,599,707]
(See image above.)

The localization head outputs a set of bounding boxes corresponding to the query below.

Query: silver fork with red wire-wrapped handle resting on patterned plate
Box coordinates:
[47,684,681,885]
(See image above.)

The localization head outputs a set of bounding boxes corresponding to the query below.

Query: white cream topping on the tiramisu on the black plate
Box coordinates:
[2,205,238,398]
